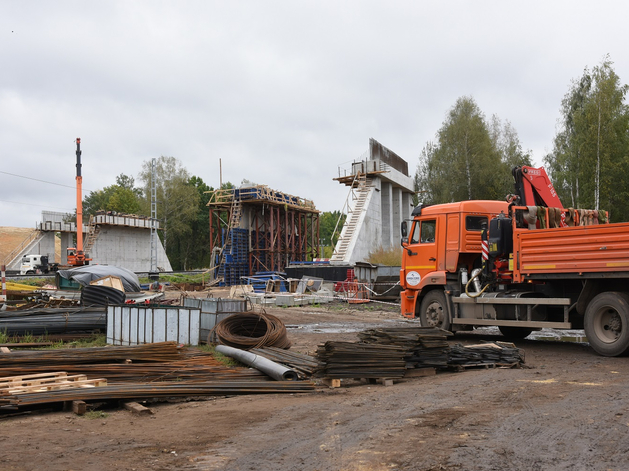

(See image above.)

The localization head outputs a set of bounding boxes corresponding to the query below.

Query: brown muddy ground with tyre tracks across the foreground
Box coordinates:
[0,304,629,471]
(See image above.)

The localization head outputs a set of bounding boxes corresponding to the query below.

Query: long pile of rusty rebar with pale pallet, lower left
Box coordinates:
[0,342,314,411]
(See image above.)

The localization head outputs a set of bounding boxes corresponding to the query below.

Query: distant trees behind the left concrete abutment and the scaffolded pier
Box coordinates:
[83,156,343,270]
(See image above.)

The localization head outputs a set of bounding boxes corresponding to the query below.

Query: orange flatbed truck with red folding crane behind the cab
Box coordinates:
[400,167,629,356]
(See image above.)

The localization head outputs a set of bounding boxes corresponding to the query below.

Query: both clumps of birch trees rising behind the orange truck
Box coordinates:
[414,56,629,222]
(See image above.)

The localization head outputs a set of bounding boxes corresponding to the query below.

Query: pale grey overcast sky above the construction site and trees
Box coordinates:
[0,0,629,227]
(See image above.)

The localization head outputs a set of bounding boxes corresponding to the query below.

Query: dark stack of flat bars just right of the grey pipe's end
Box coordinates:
[317,341,406,379]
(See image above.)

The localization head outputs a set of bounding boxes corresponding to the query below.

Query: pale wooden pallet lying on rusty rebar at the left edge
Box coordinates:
[0,371,107,396]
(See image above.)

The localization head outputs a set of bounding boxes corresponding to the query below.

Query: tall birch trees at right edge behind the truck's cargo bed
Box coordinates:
[545,56,629,220]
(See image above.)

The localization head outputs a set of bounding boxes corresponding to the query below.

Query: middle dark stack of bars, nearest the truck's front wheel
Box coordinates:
[358,327,452,368]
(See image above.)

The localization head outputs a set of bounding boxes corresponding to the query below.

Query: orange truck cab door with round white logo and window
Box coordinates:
[405,217,443,288]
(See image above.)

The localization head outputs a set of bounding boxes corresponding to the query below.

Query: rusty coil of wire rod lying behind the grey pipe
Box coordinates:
[208,312,291,350]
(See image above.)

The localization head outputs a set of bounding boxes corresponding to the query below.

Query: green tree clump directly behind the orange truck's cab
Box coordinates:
[414,97,516,203]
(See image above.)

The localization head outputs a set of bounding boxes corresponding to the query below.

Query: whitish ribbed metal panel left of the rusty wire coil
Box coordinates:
[107,306,201,345]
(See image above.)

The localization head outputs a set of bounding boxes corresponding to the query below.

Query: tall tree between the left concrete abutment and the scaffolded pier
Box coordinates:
[139,156,199,270]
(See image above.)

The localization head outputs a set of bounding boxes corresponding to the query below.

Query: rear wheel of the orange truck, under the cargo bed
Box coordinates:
[583,291,629,357]
